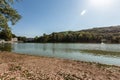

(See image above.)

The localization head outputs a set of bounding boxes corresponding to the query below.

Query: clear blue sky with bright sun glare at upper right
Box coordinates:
[10,0,120,37]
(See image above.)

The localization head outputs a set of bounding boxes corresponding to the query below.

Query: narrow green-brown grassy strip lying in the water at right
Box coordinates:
[81,50,120,57]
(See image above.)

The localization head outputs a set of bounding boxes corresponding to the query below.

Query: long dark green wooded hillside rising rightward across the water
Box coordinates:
[34,26,120,43]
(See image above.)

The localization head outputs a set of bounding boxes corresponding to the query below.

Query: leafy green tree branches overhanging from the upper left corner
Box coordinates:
[0,0,21,38]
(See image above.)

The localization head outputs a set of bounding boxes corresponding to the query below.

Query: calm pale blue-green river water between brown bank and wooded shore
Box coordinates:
[0,43,120,66]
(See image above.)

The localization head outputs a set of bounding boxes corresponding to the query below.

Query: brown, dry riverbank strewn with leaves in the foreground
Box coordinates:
[0,52,120,80]
